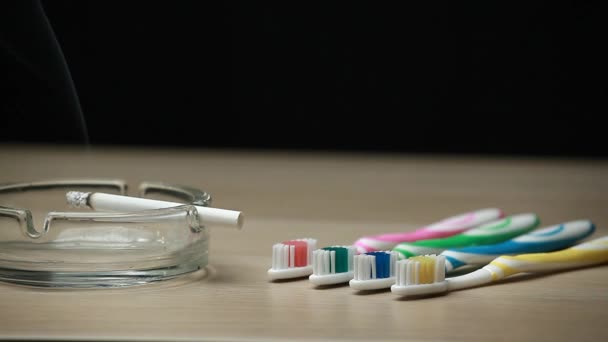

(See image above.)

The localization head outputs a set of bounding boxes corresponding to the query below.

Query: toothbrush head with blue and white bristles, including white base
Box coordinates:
[349,251,398,290]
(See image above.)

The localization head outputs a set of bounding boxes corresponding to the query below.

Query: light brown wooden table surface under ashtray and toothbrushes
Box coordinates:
[0,145,608,341]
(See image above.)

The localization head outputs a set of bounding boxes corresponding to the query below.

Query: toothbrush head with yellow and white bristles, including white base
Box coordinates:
[391,255,448,297]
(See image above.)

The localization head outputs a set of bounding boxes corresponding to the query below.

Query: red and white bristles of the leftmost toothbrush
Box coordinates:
[272,239,317,270]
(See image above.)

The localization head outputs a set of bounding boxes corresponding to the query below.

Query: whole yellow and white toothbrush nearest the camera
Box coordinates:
[391,236,608,296]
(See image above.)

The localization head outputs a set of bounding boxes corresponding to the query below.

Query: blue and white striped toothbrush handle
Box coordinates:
[441,220,595,273]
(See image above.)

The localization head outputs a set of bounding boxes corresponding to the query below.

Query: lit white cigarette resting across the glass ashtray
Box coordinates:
[66,191,244,229]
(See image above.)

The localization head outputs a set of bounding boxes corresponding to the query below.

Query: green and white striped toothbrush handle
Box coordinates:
[393,213,540,258]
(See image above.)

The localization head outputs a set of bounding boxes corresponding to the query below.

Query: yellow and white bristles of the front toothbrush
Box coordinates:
[395,255,445,286]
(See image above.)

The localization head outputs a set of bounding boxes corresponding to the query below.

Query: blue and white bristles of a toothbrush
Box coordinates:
[353,251,398,280]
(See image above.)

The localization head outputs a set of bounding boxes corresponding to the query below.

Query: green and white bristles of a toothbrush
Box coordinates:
[312,246,355,275]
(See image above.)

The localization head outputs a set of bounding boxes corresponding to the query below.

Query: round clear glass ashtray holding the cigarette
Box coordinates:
[0,180,211,288]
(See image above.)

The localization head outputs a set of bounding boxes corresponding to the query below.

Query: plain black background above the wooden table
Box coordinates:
[0,1,608,157]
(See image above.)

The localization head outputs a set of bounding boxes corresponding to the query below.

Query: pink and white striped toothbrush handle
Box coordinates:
[355,208,504,253]
